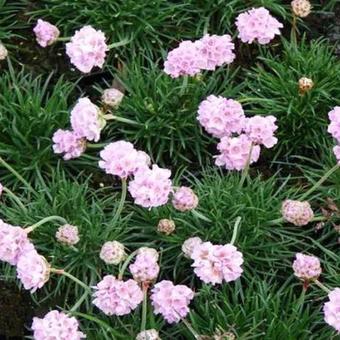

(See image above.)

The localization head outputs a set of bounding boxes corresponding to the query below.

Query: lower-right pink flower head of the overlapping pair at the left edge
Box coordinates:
[17,249,50,293]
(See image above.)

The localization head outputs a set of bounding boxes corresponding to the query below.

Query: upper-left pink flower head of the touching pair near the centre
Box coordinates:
[99,140,150,178]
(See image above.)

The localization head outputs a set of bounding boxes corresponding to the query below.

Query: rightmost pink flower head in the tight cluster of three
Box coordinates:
[245,116,277,148]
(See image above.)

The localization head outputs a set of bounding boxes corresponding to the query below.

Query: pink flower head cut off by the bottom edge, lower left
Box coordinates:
[32,310,86,340]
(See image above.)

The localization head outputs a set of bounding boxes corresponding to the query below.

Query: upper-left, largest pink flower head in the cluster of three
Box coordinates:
[197,95,245,138]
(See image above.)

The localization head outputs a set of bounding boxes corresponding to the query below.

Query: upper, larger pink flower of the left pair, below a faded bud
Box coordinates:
[71,97,105,142]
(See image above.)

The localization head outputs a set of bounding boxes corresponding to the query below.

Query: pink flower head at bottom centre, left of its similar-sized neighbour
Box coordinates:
[93,275,143,316]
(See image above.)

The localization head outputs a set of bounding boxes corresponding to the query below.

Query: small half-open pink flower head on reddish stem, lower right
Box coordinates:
[293,253,321,281]
